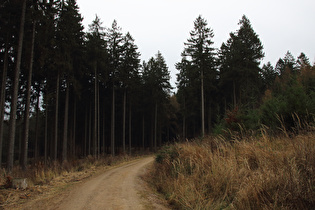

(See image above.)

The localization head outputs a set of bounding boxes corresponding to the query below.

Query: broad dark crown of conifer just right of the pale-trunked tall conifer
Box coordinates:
[219,15,264,106]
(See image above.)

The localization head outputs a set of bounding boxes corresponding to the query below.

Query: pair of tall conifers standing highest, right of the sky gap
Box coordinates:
[176,13,264,136]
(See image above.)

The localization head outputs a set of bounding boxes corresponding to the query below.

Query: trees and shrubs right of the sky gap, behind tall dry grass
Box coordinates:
[176,16,315,138]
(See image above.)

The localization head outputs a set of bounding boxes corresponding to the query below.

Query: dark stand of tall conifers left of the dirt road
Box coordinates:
[0,0,175,170]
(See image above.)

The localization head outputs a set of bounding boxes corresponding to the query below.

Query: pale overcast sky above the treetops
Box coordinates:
[77,0,315,86]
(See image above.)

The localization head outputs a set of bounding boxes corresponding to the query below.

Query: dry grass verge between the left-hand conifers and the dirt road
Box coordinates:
[0,154,145,209]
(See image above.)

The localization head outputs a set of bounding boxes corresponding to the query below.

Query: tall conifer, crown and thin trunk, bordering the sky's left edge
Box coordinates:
[56,0,84,161]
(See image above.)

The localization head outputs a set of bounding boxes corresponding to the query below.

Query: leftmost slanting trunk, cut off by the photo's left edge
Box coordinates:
[0,28,9,165]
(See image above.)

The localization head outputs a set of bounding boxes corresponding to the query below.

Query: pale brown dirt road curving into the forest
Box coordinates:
[20,157,167,210]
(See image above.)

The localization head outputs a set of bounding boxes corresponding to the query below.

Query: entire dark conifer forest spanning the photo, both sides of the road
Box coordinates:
[0,0,315,170]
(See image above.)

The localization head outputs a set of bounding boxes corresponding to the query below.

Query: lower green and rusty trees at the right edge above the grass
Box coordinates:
[260,51,315,130]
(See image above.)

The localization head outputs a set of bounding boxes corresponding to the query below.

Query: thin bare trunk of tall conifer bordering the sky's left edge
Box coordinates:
[62,82,70,162]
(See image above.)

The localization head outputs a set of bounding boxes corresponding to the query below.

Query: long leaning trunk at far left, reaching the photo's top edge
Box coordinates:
[7,0,26,172]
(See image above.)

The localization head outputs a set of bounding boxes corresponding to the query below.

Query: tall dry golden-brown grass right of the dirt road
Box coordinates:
[150,133,315,209]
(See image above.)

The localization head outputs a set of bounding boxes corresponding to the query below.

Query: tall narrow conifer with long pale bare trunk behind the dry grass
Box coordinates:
[177,16,217,136]
